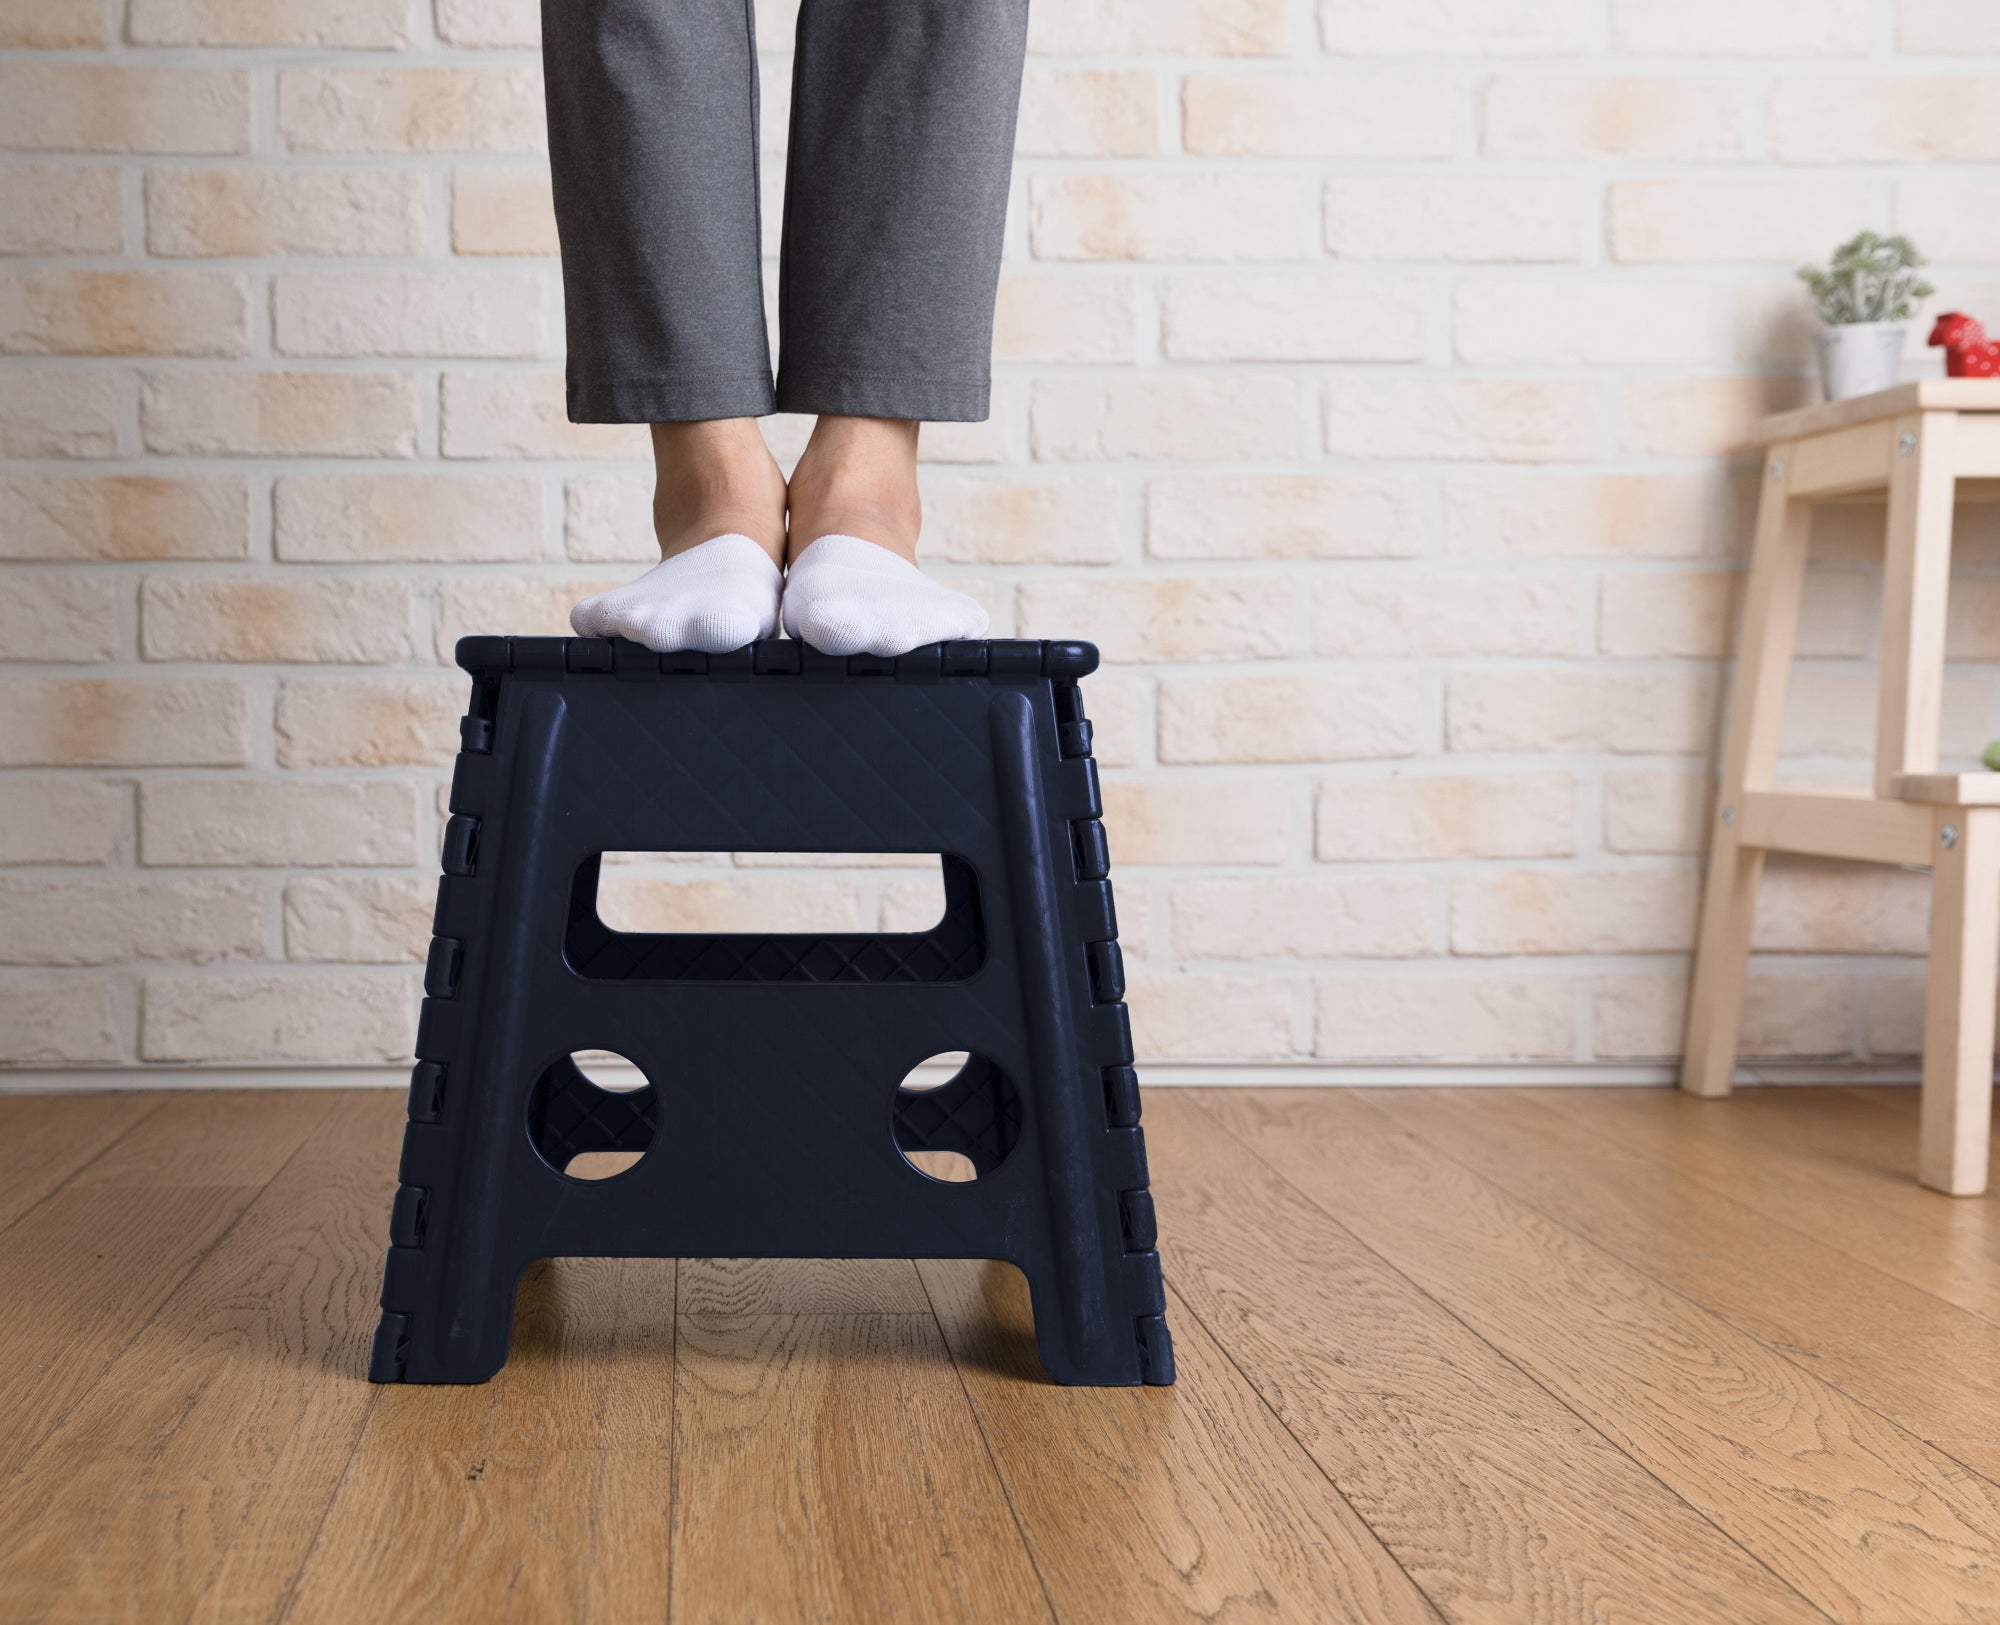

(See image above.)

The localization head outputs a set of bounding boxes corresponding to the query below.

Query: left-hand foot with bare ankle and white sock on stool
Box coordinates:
[570,418,786,654]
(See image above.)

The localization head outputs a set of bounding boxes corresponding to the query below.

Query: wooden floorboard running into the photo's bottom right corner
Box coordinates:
[1204,1093,2000,1621]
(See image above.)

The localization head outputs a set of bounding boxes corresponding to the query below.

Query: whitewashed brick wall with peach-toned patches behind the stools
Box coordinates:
[0,0,2000,1069]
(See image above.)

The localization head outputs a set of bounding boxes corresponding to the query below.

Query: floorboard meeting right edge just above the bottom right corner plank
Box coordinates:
[1362,1089,2000,1481]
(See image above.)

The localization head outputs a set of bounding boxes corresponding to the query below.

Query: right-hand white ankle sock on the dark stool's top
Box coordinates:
[784,534,986,654]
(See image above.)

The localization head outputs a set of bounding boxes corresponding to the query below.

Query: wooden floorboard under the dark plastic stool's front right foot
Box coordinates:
[918,1261,1438,1625]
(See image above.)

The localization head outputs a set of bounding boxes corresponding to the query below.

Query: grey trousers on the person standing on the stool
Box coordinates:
[542,0,1028,422]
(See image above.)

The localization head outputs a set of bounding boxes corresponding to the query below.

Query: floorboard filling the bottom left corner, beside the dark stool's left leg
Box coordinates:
[0,1095,402,1625]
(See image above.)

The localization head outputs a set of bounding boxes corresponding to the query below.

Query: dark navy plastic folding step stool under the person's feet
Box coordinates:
[368,636,1174,1385]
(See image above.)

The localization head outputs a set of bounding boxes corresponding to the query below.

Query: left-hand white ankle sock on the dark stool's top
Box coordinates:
[570,532,782,654]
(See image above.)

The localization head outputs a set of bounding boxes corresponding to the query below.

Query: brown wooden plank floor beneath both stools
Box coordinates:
[0,1089,2000,1625]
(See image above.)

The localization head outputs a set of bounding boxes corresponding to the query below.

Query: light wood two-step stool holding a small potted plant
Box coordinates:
[1680,378,2000,1197]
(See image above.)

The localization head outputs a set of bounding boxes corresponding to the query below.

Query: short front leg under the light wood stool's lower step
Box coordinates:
[1916,806,2000,1197]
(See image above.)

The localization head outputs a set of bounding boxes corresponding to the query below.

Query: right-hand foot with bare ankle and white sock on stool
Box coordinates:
[784,416,986,654]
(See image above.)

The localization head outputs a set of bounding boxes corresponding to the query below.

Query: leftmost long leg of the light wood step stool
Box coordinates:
[1680,446,1812,1097]
